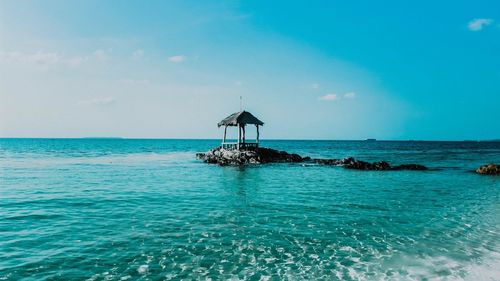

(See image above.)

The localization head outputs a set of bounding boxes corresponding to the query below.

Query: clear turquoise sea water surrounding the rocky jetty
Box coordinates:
[0,139,500,280]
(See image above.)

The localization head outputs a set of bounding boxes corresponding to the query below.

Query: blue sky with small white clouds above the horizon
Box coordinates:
[0,0,500,140]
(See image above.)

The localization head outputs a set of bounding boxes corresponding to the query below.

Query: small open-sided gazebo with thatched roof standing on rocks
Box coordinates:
[217,110,264,150]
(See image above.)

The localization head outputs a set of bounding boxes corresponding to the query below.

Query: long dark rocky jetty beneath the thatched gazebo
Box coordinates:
[196,147,428,171]
